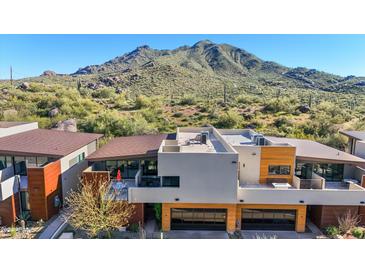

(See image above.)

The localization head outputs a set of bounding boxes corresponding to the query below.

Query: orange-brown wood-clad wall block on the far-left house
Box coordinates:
[27,160,61,220]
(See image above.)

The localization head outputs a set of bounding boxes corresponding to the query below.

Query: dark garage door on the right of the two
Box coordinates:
[242,208,296,230]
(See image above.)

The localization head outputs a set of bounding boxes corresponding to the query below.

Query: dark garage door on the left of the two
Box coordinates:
[171,208,227,230]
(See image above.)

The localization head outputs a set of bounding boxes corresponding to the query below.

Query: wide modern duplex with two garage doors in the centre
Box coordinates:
[83,127,365,232]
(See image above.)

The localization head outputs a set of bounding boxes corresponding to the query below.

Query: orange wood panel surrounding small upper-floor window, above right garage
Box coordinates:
[260,146,296,184]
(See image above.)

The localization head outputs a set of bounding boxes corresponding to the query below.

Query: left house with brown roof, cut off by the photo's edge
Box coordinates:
[0,122,102,225]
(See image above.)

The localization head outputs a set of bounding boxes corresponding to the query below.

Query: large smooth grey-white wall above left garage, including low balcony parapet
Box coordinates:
[129,152,238,203]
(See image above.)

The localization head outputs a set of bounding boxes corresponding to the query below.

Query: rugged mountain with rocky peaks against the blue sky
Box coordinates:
[68,40,365,93]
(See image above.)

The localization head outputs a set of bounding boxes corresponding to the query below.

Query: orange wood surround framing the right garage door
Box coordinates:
[236,204,307,232]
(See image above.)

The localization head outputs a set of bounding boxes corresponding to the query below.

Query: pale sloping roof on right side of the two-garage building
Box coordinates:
[267,137,365,166]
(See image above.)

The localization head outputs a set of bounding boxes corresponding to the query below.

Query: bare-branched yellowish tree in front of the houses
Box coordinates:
[65,178,134,238]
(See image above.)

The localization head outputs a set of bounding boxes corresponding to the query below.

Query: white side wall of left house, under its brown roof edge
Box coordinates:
[61,141,96,198]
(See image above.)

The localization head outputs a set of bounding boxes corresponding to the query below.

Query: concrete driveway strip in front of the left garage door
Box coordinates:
[164,230,229,239]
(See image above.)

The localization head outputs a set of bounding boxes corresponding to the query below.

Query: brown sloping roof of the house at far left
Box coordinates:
[0,129,103,158]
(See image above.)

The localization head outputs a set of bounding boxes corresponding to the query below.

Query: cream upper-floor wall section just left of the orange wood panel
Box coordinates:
[234,146,261,184]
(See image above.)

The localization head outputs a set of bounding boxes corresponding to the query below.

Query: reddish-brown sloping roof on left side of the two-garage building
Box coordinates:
[87,134,168,161]
